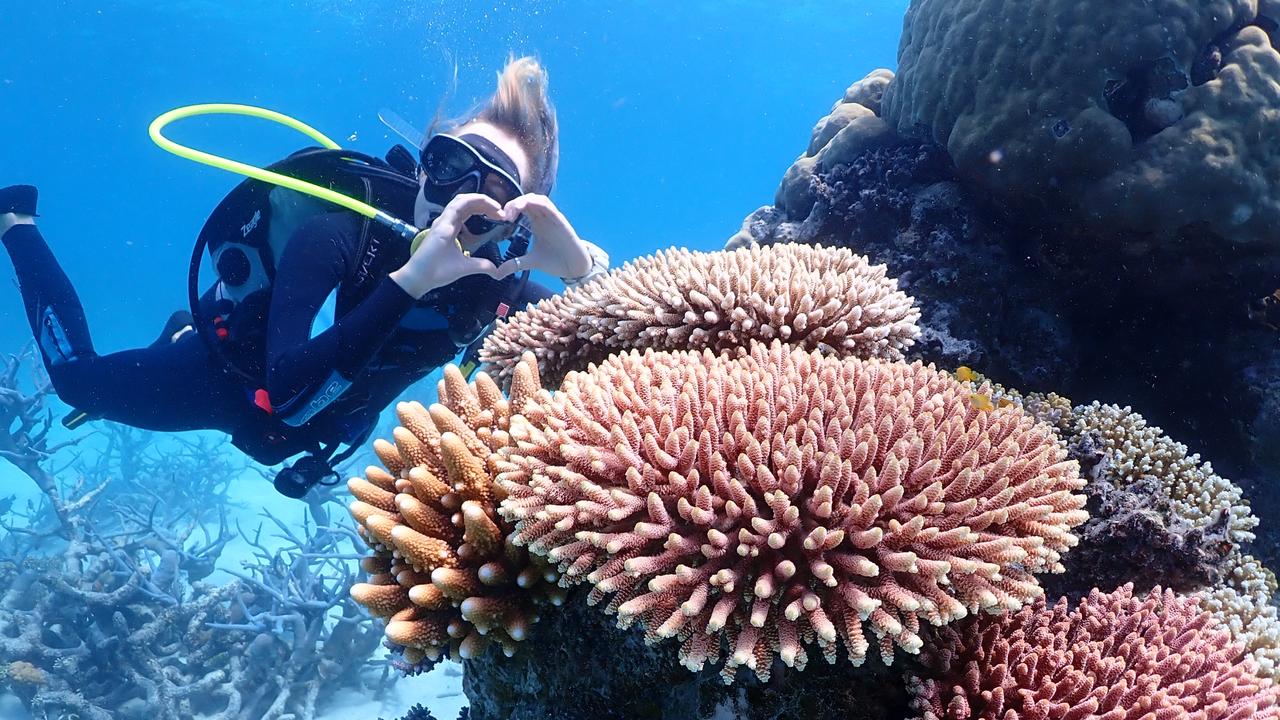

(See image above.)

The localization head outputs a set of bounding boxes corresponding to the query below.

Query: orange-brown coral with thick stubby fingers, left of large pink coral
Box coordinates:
[348,363,563,664]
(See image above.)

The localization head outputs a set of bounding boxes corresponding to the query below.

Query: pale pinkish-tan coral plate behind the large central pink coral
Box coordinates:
[480,245,920,386]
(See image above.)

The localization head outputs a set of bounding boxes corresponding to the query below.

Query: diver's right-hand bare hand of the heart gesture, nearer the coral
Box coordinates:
[494,192,591,279]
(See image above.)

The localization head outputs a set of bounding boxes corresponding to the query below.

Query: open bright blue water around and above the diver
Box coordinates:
[0,0,906,356]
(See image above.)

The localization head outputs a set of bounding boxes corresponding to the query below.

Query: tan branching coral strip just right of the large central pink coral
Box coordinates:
[1070,402,1258,543]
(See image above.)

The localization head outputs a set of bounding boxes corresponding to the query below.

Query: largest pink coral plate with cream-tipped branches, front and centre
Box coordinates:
[498,341,1085,682]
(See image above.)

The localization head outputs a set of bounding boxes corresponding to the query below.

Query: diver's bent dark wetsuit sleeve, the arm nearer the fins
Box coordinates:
[266,214,413,406]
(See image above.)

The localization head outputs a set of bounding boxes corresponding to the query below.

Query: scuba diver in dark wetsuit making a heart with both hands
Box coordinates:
[0,58,608,497]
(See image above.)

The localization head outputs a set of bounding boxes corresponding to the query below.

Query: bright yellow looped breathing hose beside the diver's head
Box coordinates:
[147,102,420,240]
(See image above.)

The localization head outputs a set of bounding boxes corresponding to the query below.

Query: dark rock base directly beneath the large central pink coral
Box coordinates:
[463,591,906,720]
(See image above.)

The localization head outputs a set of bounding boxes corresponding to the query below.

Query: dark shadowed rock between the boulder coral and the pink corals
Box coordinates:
[733,140,1280,566]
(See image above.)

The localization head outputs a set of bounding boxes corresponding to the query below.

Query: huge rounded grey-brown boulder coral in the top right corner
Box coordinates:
[883,0,1280,245]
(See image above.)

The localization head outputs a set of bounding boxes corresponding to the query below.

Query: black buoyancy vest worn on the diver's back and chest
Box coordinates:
[187,145,529,481]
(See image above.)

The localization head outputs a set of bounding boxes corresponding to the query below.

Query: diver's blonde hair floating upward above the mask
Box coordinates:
[426,54,559,195]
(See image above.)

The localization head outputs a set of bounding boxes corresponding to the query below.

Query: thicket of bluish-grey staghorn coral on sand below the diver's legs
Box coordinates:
[0,343,394,720]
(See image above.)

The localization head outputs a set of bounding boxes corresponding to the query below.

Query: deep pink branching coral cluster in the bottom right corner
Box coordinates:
[910,585,1280,720]
